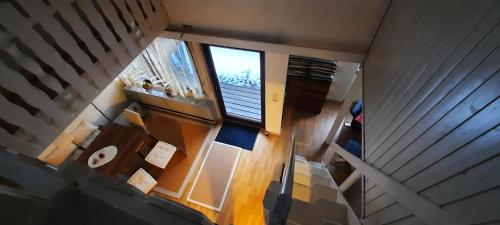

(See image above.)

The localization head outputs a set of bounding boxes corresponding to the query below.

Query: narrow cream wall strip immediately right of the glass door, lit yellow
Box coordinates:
[265,52,288,134]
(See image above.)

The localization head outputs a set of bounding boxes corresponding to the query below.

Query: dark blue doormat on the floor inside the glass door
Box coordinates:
[215,121,259,151]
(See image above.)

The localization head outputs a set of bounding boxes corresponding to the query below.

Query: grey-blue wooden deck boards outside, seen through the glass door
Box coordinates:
[220,83,262,122]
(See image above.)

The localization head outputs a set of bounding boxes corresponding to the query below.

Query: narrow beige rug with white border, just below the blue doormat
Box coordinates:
[187,141,241,212]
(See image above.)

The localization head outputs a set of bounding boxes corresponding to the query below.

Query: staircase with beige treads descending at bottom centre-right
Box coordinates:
[287,155,360,225]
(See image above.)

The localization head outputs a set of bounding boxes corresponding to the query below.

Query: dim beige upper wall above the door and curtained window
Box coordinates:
[165,0,389,53]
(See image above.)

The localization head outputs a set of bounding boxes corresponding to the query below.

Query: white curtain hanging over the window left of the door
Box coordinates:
[120,38,204,99]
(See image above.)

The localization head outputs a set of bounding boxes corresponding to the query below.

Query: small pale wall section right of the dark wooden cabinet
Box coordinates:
[327,61,360,102]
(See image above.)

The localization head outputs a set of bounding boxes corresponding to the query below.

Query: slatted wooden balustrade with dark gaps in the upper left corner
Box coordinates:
[0,0,168,157]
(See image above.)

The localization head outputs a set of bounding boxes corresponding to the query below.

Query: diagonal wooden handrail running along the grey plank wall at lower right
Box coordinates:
[329,143,465,225]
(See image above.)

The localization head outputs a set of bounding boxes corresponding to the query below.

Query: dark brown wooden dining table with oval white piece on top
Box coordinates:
[78,123,156,177]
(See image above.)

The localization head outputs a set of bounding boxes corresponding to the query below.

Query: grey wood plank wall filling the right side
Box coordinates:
[364,0,500,225]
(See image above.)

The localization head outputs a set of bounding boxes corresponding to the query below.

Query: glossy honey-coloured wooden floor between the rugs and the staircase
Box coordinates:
[154,101,340,225]
